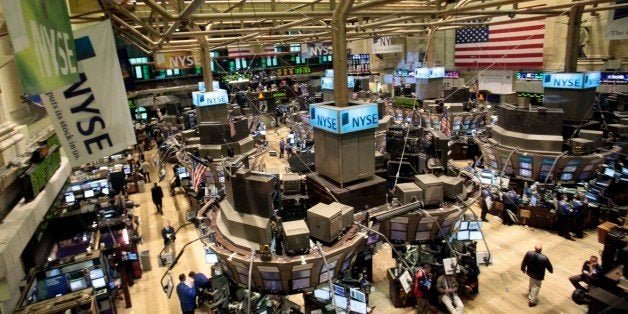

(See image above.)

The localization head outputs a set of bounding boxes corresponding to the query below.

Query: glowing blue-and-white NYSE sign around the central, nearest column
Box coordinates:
[310,103,379,134]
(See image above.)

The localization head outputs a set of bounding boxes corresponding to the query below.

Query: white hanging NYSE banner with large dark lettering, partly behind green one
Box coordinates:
[41,20,136,166]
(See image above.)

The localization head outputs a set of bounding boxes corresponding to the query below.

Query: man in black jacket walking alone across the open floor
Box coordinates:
[521,244,554,307]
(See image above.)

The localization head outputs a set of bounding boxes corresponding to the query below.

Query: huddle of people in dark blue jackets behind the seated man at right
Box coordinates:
[556,192,589,240]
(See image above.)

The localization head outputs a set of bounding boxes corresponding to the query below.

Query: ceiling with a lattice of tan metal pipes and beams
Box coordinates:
[68,0,626,53]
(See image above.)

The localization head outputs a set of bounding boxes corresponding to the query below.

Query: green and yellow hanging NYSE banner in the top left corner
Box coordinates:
[0,0,79,96]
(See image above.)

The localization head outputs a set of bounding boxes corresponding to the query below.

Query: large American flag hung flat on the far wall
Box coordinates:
[454,18,545,69]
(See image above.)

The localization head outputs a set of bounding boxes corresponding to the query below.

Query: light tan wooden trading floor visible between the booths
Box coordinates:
[118,137,602,314]
